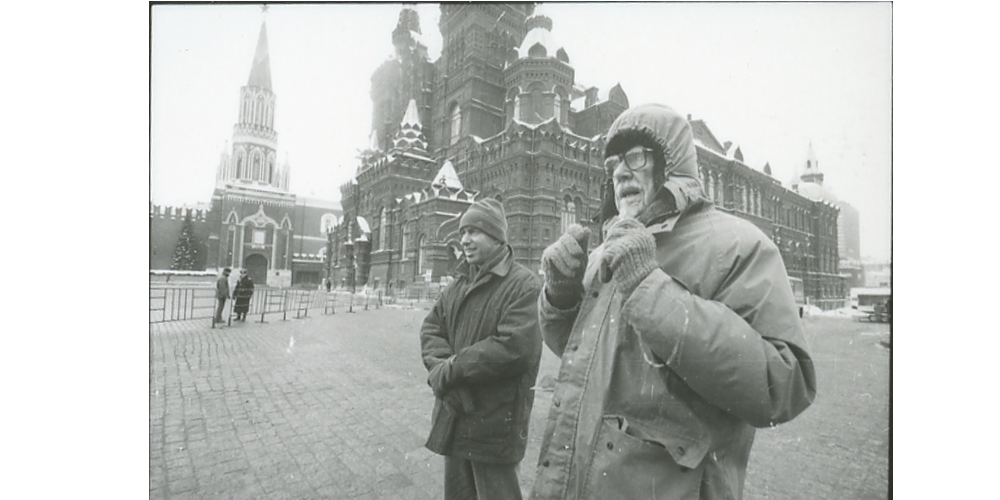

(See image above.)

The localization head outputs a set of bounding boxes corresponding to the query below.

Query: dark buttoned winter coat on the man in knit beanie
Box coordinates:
[420,246,542,463]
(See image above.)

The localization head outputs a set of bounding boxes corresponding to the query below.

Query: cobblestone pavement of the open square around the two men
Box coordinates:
[149,304,889,499]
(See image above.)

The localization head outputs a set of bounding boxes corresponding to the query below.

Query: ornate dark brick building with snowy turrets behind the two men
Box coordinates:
[332,4,847,307]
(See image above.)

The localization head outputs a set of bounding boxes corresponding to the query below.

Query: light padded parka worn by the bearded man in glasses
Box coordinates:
[531,103,816,500]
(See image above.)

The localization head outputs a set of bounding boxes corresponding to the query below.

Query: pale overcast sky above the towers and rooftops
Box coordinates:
[150,3,892,259]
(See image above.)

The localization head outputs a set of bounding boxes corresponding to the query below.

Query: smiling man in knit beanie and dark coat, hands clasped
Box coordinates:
[420,199,542,500]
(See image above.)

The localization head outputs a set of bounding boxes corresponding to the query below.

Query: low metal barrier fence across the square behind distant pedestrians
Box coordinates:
[149,287,398,328]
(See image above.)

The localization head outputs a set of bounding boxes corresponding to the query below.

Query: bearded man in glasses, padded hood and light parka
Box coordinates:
[532,104,816,500]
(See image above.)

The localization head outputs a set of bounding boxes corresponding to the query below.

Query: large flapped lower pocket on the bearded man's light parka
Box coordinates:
[583,417,704,499]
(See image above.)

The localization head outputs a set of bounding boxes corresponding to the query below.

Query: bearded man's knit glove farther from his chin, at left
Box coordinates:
[542,224,590,309]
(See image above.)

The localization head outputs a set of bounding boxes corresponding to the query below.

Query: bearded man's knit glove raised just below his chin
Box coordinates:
[601,219,658,299]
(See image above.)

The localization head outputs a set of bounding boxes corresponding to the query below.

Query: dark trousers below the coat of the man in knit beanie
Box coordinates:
[444,456,521,500]
